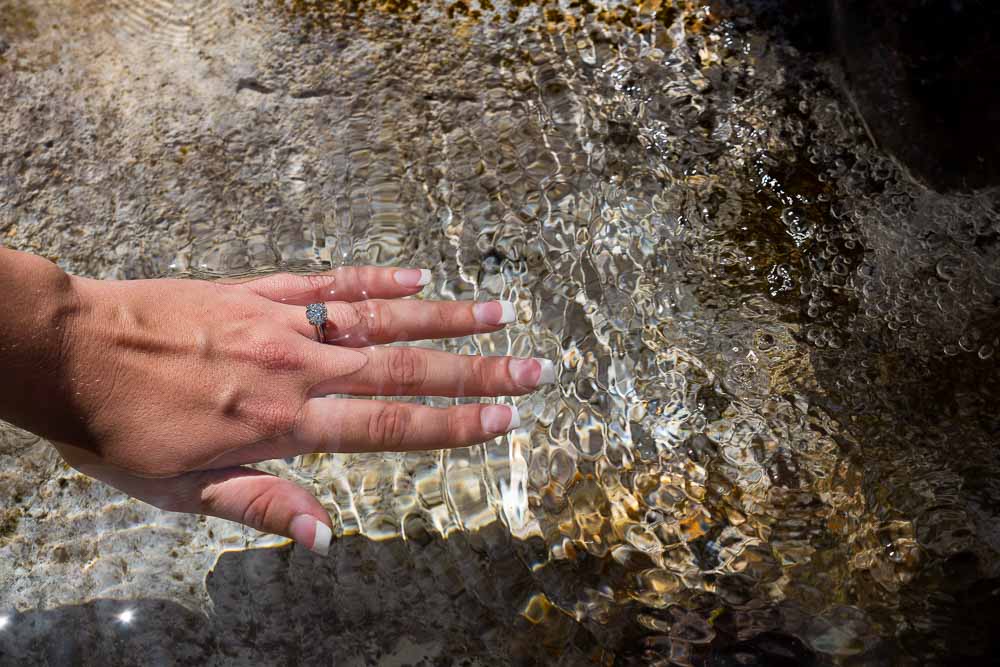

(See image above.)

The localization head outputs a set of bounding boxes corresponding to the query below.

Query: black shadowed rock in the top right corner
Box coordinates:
[833,0,1000,191]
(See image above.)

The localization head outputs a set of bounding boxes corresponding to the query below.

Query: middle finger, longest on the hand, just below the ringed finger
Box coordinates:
[310,345,556,396]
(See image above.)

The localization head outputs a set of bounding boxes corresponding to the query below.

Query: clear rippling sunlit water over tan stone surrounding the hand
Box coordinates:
[0,0,1000,664]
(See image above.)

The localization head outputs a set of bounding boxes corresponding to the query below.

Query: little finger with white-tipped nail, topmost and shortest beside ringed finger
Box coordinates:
[240,266,431,306]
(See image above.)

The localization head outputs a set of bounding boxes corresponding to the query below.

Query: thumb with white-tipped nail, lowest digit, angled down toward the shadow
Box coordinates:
[78,465,333,556]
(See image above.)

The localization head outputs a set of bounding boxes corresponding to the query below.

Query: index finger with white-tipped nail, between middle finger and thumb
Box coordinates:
[202,398,521,466]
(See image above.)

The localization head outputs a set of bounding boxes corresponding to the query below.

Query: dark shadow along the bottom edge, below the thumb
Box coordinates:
[0,537,828,667]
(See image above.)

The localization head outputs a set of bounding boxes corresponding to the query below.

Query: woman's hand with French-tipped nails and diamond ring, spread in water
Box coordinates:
[46,268,555,553]
